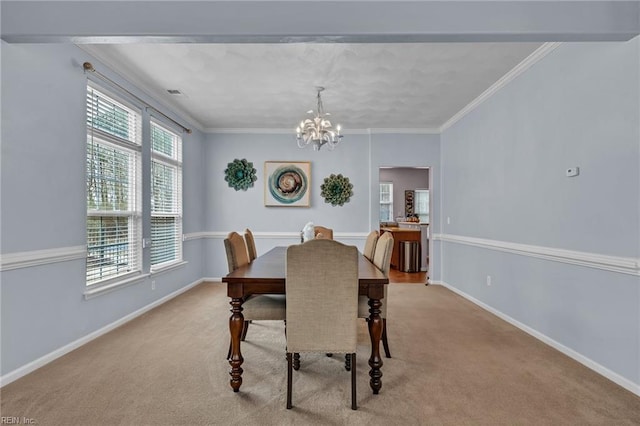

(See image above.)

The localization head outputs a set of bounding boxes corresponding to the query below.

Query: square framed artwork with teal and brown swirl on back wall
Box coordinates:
[264,161,311,207]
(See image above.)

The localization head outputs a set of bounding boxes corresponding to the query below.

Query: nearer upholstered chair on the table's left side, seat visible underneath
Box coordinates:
[224,232,286,346]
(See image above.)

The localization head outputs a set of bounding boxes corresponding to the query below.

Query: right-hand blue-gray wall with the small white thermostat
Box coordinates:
[436,38,640,392]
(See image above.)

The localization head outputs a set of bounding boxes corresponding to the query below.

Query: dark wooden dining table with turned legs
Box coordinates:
[222,246,389,394]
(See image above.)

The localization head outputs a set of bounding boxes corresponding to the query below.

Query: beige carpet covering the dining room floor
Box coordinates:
[1,284,640,425]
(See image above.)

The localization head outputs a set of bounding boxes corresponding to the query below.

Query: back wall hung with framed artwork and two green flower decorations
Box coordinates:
[204,133,440,278]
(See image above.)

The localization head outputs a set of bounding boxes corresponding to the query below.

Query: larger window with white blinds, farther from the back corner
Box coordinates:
[86,85,142,285]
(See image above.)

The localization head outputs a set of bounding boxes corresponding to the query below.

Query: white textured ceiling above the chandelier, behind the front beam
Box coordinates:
[82,43,541,133]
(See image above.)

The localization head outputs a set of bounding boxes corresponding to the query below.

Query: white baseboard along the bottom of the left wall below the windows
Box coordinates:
[0,278,204,387]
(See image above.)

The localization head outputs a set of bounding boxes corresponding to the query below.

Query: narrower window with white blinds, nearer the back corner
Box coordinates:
[151,121,182,269]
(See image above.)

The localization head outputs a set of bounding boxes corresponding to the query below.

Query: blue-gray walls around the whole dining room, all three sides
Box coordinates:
[0,39,640,390]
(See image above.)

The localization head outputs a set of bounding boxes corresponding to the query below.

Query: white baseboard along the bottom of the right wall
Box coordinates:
[431,281,640,396]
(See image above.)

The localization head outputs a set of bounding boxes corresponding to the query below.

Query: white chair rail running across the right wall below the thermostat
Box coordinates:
[432,234,640,276]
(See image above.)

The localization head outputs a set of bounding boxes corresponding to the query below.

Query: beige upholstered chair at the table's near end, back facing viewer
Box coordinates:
[285,239,359,410]
